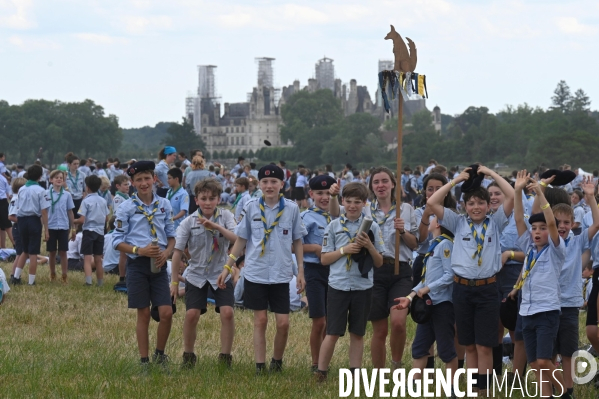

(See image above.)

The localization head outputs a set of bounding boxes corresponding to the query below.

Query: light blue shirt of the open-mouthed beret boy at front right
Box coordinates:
[518,230,564,316]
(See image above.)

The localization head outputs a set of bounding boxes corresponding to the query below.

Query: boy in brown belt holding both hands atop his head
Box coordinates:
[427,165,514,395]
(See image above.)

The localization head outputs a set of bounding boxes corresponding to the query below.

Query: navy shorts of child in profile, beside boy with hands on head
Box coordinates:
[412,301,457,363]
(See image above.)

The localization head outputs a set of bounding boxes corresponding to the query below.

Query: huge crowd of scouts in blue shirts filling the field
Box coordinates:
[0,146,599,397]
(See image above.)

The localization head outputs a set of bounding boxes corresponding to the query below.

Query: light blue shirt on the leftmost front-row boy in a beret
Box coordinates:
[112,194,175,258]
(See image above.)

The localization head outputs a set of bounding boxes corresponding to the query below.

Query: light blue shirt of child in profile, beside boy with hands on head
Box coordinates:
[412,240,453,305]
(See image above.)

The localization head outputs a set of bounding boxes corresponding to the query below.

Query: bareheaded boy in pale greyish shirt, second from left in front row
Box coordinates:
[169,178,237,367]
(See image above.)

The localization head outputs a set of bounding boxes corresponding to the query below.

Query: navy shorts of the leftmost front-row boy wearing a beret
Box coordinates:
[127,256,172,309]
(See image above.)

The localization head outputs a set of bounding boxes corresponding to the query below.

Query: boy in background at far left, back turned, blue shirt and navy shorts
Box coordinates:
[14,165,50,285]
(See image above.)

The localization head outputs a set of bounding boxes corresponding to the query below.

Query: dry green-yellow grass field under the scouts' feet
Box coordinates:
[0,263,597,399]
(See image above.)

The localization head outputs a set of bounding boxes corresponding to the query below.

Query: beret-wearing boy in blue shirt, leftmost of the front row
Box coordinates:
[112,161,175,368]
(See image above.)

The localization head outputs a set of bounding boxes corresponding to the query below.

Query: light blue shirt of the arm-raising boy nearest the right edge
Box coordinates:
[559,233,589,308]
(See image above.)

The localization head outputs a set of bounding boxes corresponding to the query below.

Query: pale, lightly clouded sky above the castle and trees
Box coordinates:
[0,0,599,128]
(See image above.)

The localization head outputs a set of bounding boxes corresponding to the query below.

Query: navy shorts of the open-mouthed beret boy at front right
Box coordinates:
[522,310,559,363]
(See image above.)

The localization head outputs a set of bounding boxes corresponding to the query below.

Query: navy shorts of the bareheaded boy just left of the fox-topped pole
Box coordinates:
[328,286,372,337]
